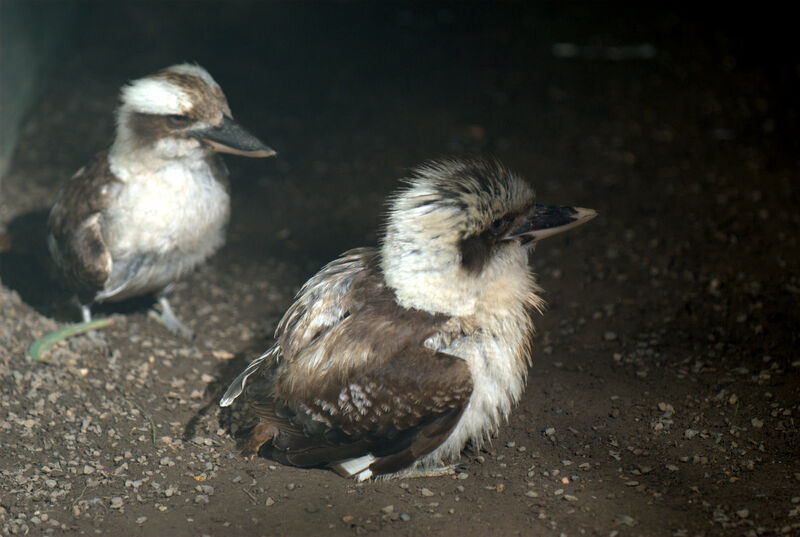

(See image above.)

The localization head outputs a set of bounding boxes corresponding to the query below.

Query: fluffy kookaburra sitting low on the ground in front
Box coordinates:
[220,158,597,481]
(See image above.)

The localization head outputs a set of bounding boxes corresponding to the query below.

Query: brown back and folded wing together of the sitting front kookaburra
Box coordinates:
[220,249,472,479]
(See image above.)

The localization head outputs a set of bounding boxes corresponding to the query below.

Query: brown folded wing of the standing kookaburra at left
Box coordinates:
[48,151,120,304]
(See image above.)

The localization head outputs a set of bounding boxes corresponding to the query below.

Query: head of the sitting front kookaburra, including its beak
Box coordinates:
[381,160,597,315]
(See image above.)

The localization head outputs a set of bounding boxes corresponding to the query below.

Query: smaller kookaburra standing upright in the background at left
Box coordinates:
[48,64,275,336]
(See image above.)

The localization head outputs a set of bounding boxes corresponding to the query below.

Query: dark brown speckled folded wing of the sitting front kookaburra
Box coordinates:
[241,347,472,475]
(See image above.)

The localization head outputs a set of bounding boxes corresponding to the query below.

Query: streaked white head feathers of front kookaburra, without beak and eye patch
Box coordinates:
[381,160,533,315]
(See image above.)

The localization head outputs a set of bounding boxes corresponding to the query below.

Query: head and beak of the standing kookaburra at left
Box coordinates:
[112,63,275,159]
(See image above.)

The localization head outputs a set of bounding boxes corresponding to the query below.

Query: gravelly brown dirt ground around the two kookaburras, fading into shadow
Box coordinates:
[0,2,800,537]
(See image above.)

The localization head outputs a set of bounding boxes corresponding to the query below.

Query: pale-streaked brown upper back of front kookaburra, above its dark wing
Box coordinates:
[276,248,448,396]
